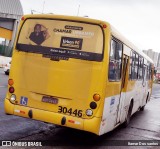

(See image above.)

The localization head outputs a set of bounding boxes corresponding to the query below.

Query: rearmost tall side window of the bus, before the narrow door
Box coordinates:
[108,40,122,81]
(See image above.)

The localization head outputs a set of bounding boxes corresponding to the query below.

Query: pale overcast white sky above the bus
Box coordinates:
[14,0,160,52]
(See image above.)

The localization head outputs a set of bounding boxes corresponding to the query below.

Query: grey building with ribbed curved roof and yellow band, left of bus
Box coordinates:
[0,0,23,56]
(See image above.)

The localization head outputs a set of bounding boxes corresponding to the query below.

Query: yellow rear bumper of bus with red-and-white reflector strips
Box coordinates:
[5,99,101,135]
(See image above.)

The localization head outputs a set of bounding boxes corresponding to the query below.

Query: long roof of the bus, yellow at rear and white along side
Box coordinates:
[21,14,153,63]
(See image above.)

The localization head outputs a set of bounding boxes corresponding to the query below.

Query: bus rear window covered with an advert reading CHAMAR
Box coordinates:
[16,19,104,61]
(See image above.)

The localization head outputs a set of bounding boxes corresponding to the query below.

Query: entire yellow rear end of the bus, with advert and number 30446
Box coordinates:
[5,15,107,134]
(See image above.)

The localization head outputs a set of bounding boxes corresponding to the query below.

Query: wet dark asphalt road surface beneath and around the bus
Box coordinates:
[0,68,160,149]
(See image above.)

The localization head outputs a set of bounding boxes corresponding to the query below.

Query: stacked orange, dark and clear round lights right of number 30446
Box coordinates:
[86,93,101,116]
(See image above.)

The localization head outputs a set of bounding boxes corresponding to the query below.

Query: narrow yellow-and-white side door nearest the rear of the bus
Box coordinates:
[115,55,129,125]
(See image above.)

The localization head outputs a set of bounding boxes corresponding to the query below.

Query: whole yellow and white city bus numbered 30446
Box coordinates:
[5,15,153,135]
